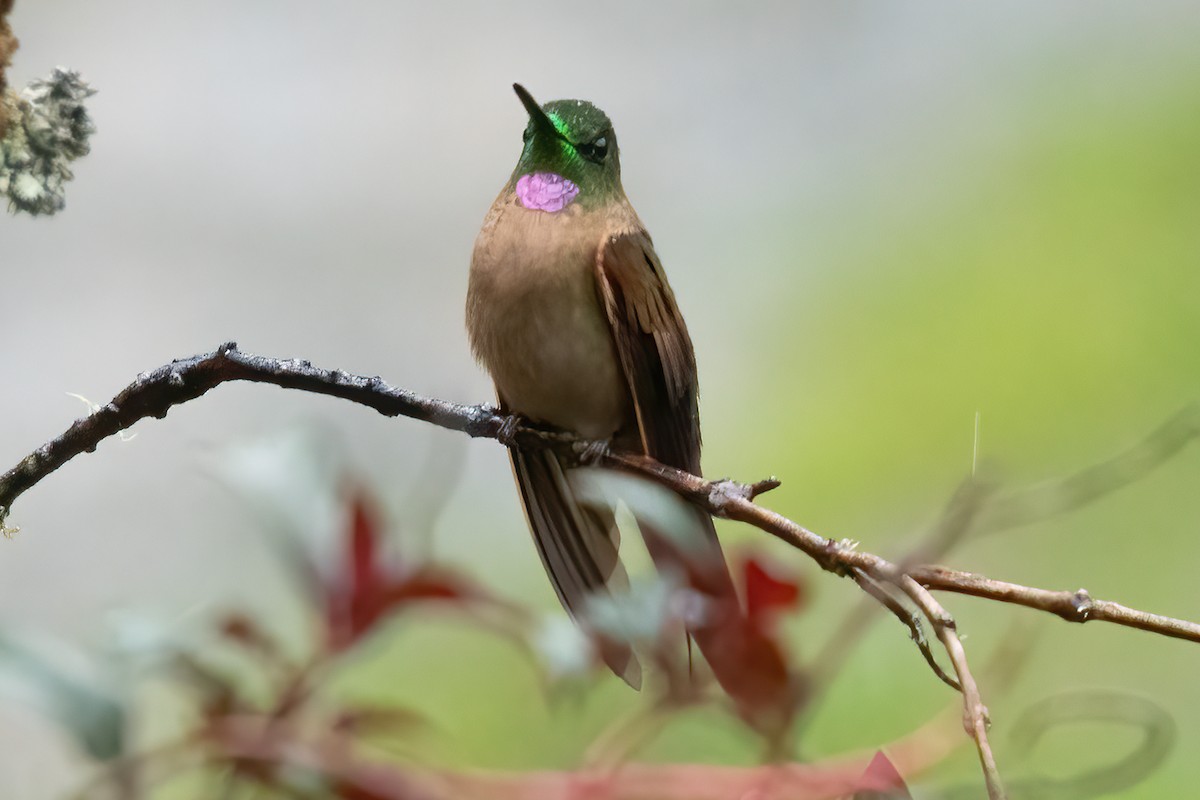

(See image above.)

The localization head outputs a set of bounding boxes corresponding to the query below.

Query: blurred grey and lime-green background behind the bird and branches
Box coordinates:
[0,0,1200,799]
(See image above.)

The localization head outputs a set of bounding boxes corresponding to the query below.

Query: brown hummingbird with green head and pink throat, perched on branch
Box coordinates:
[467,84,736,688]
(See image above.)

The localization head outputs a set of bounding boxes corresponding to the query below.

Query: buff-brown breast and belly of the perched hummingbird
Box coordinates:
[467,206,630,439]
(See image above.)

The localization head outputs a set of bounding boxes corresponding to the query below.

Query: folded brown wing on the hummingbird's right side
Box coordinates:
[596,230,700,475]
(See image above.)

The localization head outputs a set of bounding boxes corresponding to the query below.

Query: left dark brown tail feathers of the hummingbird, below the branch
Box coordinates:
[509,449,642,688]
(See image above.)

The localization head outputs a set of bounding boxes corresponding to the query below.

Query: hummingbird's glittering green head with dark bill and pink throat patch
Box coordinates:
[510,84,624,212]
